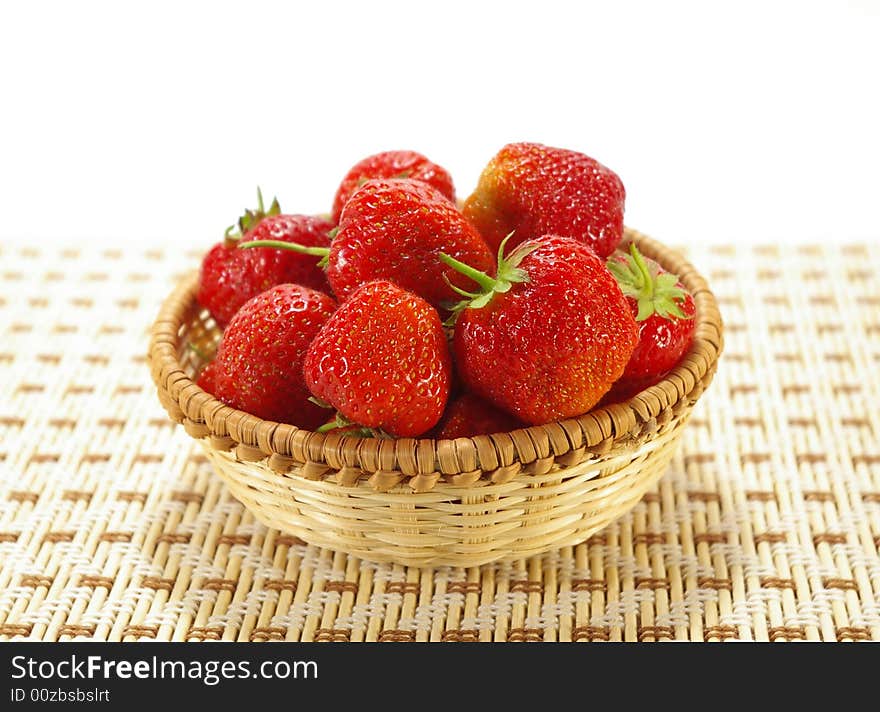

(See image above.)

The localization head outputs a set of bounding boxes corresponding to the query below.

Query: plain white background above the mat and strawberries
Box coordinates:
[0,0,880,246]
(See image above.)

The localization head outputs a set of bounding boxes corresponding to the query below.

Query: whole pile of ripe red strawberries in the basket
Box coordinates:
[198,143,695,438]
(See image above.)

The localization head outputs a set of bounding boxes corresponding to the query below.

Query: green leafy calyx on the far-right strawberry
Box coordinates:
[606,243,692,321]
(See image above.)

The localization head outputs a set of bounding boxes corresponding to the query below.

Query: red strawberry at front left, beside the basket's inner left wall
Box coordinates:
[203,284,336,430]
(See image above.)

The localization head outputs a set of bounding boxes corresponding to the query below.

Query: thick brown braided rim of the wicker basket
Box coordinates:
[147,227,723,475]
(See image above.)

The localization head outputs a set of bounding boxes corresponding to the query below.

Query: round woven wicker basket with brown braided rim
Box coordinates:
[149,230,722,566]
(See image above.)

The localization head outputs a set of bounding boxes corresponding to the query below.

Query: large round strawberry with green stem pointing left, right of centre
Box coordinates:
[442,235,638,425]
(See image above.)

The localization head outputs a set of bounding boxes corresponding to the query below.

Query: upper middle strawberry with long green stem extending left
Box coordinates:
[240,179,495,308]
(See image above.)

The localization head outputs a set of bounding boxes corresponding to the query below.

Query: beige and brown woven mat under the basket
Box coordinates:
[0,245,880,641]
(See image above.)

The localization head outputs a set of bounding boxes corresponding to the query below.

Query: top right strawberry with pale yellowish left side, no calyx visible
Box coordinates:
[463,143,626,257]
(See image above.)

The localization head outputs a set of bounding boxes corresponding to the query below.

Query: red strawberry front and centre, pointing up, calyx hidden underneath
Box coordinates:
[304,280,452,437]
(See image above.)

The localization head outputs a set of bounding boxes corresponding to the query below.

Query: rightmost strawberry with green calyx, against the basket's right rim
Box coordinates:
[608,243,696,400]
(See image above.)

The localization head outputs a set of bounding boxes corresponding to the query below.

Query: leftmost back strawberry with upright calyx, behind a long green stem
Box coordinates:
[198,191,333,328]
